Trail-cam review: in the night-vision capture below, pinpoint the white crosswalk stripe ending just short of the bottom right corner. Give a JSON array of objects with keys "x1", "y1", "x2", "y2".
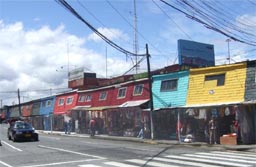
[{"x1": 166, "y1": 155, "x2": 250, "y2": 167}]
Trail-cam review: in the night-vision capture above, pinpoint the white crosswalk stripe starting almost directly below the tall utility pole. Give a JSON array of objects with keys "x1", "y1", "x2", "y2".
[{"x1": 148, "y1": 157, "x2": 223, "y2": 167}]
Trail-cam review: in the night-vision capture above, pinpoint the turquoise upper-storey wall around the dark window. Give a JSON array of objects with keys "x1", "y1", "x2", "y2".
[{"x1": 152, "y1": 71, "x2": 189, "y2": 109}]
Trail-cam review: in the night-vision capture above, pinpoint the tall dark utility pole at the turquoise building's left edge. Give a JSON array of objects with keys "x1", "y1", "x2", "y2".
[{"x1": 146, "y1": 44, "x2": 154, "y2": 140}]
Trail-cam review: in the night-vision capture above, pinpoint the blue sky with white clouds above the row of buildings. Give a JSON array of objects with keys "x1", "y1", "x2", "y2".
[{"x1": 0, "y1": 0, "x2": 256, "y2": 104}]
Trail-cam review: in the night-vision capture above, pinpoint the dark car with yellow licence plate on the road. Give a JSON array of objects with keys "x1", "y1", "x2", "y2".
[{"x1": 7, "y1": 121, "x2": 39, "y2": 142}]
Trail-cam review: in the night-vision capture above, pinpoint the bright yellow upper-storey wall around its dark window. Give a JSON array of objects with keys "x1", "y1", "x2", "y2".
[{"x1": 187, "y1": 63, "x2": 246, "y2": 105}]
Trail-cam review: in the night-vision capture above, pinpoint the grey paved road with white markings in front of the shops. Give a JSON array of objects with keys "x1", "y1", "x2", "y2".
[{"x1": 0, "y1": 125, "x2": 256, "y2": 167}]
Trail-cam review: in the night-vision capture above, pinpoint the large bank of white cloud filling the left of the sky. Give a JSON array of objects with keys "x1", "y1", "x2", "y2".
[{"x1": 0, "y1": 21, "x2": 130, "y2": 104}]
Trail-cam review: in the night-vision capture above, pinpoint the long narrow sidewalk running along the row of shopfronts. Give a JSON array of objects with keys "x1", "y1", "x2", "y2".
[{"x1": 37, "y1": 130, "x2": 256, "y2": 152}]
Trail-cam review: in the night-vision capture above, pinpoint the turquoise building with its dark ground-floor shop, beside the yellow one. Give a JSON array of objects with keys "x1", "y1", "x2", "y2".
[{"x1": 152, "y1": 70, "x2": 189, "y2": 139}]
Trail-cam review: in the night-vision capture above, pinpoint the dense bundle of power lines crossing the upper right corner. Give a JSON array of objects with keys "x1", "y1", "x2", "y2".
[{"x1": 160, "y1": 0, "x2": 256, "y2": 46}]
